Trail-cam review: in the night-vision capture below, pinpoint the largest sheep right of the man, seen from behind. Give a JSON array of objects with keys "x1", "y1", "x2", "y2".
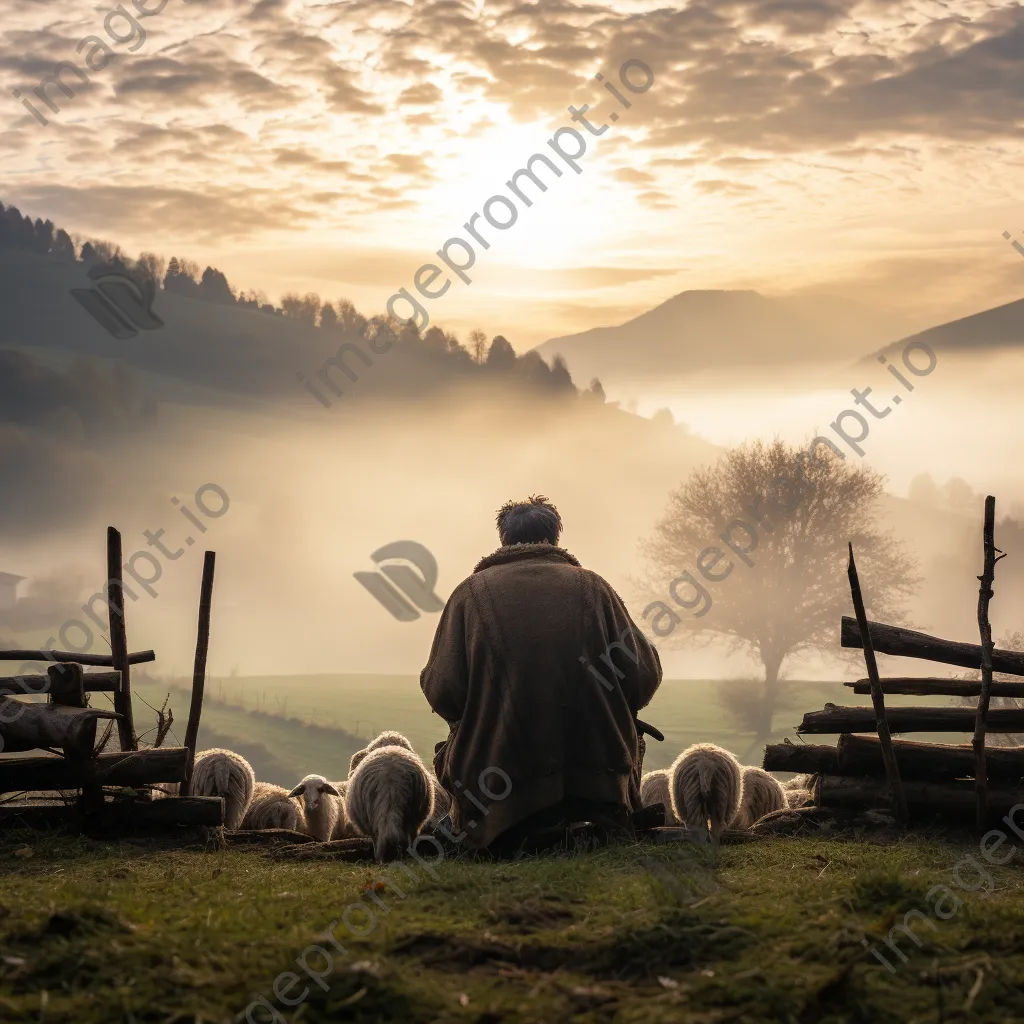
[{"x1": 669, "y1": 743, "x2": 743, "y2": 844}]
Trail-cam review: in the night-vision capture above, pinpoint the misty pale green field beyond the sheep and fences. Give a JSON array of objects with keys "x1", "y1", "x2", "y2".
[{"x1": 134, "y1": 675, "x2": 978, "y2": 784}]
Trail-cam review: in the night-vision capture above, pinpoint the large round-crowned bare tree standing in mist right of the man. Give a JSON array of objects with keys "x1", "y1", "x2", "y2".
[{"x1": 643, "y1": 439, "x2": 920, "y2": 741}]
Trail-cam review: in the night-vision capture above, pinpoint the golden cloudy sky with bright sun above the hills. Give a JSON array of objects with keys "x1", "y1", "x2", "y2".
[{"x1": 0, "y1": 0, "x2": 1024, "y2": 350}]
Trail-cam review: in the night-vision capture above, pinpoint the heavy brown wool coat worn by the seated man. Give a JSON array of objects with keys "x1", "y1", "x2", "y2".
[{"x1": 420, "y1": 544, "x2": 662, "y2": 848}]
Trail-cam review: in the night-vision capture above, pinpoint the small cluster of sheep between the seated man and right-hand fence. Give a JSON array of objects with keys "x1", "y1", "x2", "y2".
[{"x1": 640, "y1": 743, "x2": 810, "y2": 843}]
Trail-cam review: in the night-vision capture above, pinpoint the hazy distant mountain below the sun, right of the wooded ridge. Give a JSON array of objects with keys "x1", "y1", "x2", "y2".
[{"x1": 536, "y1": 291, "x2": 907, "y2": 385}]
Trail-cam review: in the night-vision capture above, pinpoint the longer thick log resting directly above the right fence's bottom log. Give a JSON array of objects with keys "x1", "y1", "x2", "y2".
[{"x1": 828, "y1": 733, "x2": 1024, "y2": 783}]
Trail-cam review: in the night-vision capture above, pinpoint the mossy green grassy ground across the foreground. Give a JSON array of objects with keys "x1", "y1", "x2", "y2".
[{"x1": 0, "y1": 833, "x2": 1024, "y2": 1024}]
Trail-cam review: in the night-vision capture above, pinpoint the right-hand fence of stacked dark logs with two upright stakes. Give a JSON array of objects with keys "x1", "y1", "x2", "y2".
[{"x1": 764, "y1": 497, "x2": 1024, "y2": 827}]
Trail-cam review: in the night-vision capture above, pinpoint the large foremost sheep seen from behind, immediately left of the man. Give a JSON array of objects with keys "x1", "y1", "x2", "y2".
[{"x1": 345, "y1": 746, "x2": 434, "y2": 863}]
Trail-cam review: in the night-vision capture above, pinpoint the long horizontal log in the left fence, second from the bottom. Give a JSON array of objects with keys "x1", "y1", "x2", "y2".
[{"x1": 0, "y1": 746, "x2": 188, "y2": 793}]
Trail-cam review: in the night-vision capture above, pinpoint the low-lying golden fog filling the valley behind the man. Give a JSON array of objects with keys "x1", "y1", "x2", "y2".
[{"x1": 0, "y1": 354, "x2": 1024, "y2": 677}]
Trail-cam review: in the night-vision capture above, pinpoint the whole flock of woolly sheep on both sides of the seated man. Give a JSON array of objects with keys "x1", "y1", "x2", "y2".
[{"x1": 169, "y1": 732, "x2": 809, "y2": 862}]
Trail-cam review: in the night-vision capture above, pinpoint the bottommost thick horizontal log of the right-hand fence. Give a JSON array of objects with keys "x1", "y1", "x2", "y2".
[{"x1": 819, "y1": 775, "x2": 1021, "y2": 821}]
